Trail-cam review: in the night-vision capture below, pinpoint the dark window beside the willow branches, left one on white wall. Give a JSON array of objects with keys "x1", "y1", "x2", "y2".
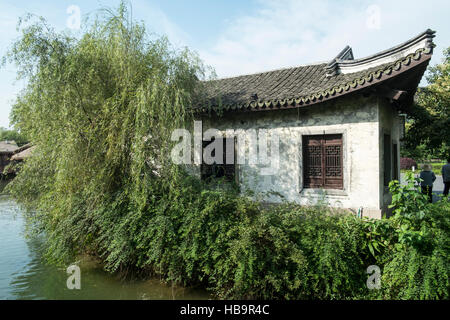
[{"x1": 201, "y1": 138, "x2": 236, "y2": 181}]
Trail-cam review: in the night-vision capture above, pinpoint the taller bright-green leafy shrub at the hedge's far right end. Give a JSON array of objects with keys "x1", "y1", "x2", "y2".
[{"x1": 380, "y1": 173, "x2": 450, "y2": 299}]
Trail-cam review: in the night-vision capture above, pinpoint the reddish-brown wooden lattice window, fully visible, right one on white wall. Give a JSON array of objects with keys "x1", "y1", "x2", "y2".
[{"x1": 303, "y1": 134, "x2": 344, "y2": 189}]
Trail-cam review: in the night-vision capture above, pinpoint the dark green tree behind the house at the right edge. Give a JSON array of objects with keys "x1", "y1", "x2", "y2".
[{"x1": 405, "y1": 47, "x2": 450, "y2": 158}]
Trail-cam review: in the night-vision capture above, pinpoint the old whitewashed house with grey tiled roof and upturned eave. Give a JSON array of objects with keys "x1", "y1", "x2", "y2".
[{"x1": 198, "y1": 30, "x2": 434, "y2": 218}]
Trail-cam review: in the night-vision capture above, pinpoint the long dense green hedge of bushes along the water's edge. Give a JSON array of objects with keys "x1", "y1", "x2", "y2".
[{"x1": 10, "y1": 162, "x2": 450, "y2": 299}]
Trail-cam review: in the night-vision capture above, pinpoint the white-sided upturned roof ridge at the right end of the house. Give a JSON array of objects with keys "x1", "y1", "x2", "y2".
[{"x1": 325, "y1": 29, "x2": 436, "y2": 77}]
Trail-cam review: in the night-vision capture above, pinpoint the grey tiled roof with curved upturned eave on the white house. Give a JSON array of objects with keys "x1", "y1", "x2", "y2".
[{"x1": 200, "y1": 30, "x2": 434, "y2": 111}]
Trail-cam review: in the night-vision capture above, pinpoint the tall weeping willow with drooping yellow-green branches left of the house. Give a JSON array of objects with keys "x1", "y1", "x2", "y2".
[{"x1": 5, "y1": 4, "x2": 205, "y2": 269}]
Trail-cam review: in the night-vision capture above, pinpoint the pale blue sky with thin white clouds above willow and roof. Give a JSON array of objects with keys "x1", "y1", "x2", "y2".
[{"x1": 0, "y1": 0, "x2": 450, "y2": 127}]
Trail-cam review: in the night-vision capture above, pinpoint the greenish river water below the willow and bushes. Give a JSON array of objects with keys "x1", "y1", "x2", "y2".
[{"x1": 0, "y1": 194, "x2": 210, "y2": 300}]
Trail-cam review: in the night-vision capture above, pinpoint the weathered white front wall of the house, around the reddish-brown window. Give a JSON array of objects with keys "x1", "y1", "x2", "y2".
[{"x1": 203, "y1": 95, "x2": 382, "y2": 216}]
